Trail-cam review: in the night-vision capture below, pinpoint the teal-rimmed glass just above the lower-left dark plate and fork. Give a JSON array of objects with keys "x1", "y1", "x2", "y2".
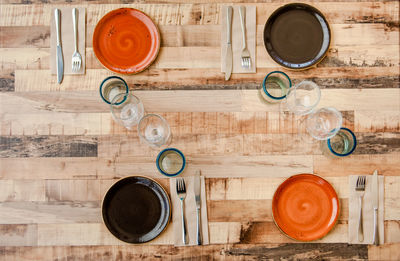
[{"x1": 156, "y1": 148, "x2": 186, "y2": 177}]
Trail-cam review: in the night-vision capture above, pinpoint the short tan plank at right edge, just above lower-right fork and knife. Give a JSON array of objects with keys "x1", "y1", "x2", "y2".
[{"x1": 313, "y1": 154, "x2": 400, "y2": 176}]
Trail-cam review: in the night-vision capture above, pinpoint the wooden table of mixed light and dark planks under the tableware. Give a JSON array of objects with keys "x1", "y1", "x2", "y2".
[{"x1": 0, "y1": 0, "x2": 400, "y2": 261}]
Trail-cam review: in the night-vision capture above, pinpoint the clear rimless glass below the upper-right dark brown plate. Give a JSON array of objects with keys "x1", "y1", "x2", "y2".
[{"x1": 285, "y1": 81, "x2": 321, "y2": 115}]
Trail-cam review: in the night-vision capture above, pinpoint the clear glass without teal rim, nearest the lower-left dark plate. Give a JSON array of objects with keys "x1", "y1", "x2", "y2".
[{"x1": 138, "y1": 114, "x2": 171, "y2": 148}]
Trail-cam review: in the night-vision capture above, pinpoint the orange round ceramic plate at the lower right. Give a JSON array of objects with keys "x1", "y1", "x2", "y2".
[{"x1": 272, "y1": 174, "x2": 339, "y2": 241}]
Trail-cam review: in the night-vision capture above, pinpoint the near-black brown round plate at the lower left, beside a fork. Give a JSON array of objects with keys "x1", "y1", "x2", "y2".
[{"x1": 102, "y1": 176, "x2": 171, "y2": 243}]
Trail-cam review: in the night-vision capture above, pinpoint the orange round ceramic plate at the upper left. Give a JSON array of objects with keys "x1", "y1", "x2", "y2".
[{"x1": 93, "y1": 8, "x2": 160, "y2": 74}]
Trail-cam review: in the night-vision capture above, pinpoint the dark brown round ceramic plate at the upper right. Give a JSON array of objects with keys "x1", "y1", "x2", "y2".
[{"x1": 264, "y1": 3, "x2": 331, "y2": 69}]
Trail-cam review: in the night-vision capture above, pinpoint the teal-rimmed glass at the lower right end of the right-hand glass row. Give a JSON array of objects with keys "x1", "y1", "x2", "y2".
[{"x1": 321, "y1": 128, "x2": 357, "y2": 157}]
